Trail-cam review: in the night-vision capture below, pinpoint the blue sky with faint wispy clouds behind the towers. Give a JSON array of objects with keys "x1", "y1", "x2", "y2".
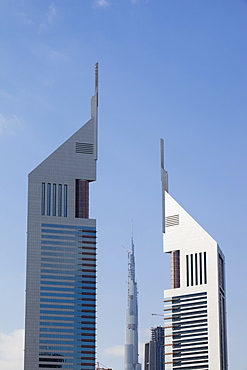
[{"x1": 0, "y1": 0, "x2": 247, "y2": 370}]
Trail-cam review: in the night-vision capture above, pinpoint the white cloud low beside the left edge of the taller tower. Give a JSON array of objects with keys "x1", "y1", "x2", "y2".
[{"x1": 0, "y1": 329, "x2": 24, "y2": 370}]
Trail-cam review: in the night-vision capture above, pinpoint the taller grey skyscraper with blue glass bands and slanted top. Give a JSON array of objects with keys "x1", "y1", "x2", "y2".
[{"x1": 24, "y1": 64, "x2": 98, "y2": 370}]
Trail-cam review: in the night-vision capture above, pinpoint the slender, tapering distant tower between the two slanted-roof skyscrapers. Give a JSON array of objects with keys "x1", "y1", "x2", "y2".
[{"x1": 124, "y1": 236, "x2": 141, "y2": 370}]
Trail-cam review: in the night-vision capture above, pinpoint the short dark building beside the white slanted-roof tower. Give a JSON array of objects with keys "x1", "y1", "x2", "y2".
[{"x1": 144, "y1": 326, "x2": 165, "y2": 370}]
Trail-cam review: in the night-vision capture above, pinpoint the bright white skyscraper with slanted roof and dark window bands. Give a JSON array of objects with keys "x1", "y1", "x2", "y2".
[{"x1": 161, "y1": 140, "x2": 228, "y2": 370}]
